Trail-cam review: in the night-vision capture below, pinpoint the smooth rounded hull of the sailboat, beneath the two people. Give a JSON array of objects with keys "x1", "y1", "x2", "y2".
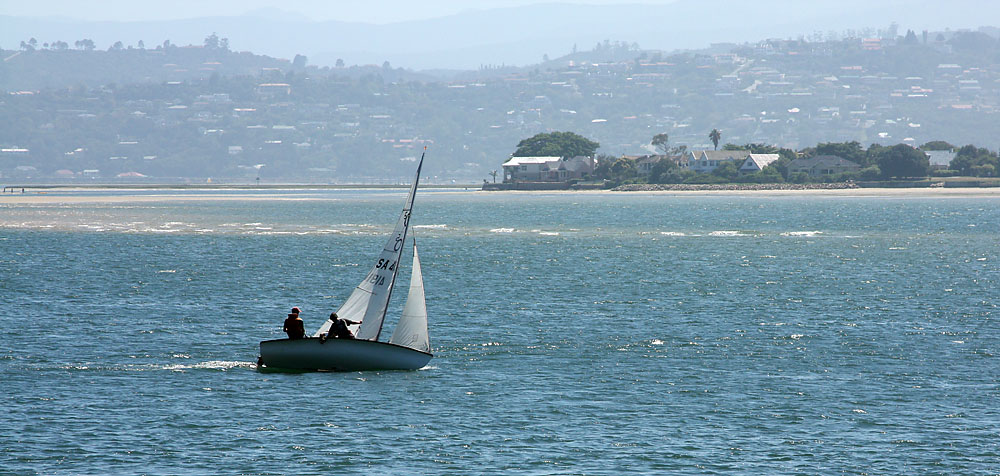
[{"x1": 259, "y1": 338, "x2": 434, "y2": 372}]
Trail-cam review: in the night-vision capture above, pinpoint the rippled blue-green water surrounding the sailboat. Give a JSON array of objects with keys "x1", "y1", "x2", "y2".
[{"x1": 0, "y1": 191, "x2": 1000, "y2": 474}]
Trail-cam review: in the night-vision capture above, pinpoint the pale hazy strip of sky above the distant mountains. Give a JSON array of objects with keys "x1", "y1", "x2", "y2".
[{"x1": 0, "y1": 0, "x2": 675, "y2": 23}]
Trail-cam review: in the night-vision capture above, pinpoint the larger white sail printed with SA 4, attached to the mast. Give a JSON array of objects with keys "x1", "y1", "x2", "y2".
[{"x1": 314, "y1": 154, "x2": 424, "y2": 340}]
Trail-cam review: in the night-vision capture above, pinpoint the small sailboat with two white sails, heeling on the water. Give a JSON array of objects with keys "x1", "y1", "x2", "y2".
[{"x1": 257, "y1": 151, "x2": 433, "y2": 371}]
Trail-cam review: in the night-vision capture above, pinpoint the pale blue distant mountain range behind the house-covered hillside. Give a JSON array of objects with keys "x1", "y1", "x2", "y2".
[{"x1": 0, "y1": 0, "x2": 1000, "y2": 70}]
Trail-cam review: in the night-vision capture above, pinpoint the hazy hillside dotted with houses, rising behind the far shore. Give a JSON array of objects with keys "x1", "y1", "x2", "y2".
[{"x1": 0, "y1": 25, "x2": 1000, "y2": 183}]
